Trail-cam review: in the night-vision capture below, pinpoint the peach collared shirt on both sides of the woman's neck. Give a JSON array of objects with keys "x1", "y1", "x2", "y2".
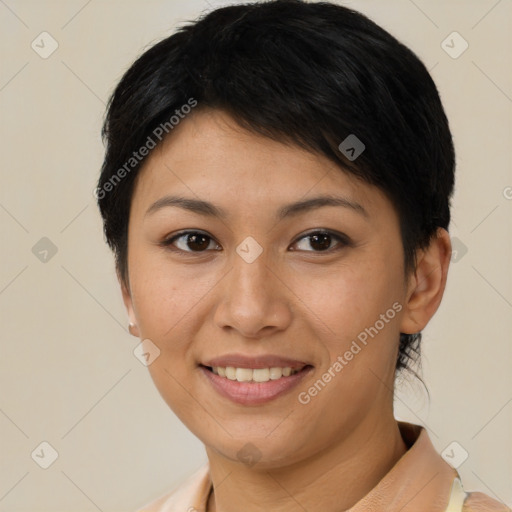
[{"x1": 138, "y1": 421, "x2": 512, "y2": 512}]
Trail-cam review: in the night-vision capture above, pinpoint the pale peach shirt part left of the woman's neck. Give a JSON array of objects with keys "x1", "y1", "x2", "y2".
[{"x1": 137, "y1": 464, "x2": 211, "y2": 512}]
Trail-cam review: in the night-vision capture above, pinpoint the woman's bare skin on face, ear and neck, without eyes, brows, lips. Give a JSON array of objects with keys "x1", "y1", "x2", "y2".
[{"x1": 121, "y1": 110, "x2": 451, "y2": 512}]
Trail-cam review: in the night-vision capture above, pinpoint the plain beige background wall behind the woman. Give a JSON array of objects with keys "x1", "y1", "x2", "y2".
[{"x1": 0, "y1": 0, "x2": 512, "y2": 512}]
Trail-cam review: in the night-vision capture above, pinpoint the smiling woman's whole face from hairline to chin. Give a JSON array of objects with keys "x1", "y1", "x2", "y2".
[{"x1": 123, "y1": 111, "x2": 416, "y2": 467}]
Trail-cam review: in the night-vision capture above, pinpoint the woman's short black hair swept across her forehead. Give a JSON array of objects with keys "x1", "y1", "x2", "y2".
[{"x1": 96, "y1": 0, "x2": 455, "y2": 376}]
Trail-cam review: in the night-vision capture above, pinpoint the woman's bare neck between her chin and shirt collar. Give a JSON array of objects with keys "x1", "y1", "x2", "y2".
[{"x1": 207, "y1": 417, "x2": 407, "y2": 512}]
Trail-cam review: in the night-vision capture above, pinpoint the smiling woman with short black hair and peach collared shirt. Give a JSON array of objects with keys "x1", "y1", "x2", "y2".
[{"x1": 97, "y1": 0, "x2": 507, "y2": 512}]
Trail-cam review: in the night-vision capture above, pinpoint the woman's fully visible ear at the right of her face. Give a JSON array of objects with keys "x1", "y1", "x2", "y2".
[{"x1": 400, "y1": 228, "x2": 452, "y2": 334}]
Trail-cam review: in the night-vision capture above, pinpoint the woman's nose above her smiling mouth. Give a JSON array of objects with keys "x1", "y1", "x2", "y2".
[{"x1": 214, "y1": 252, "x2": 292, "y2": 338}]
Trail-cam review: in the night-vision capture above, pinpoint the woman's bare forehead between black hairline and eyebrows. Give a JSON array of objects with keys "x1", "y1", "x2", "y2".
[{"x1": 132, "y1": 110, "x2": 391, "y2": 221}]
